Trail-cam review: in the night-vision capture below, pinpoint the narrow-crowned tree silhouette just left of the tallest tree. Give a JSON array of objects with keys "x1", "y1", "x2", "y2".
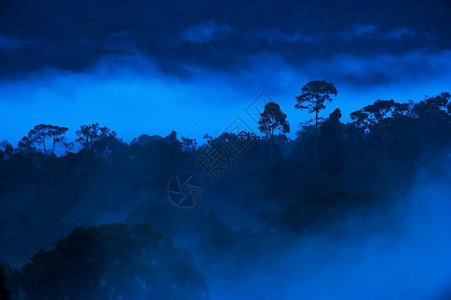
[{"x1": 258, "y1": 102, "x2": 290, "y2": 160}]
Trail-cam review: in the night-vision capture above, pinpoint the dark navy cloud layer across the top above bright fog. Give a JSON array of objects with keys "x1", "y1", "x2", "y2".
[{"x1": 0, "y1": 0, "x2": 451, "y2": 79}]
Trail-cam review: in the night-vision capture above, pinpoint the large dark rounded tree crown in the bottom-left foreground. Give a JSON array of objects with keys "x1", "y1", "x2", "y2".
[{"x1": 22, "y1": 224, "x2": 207, "y2": 299}]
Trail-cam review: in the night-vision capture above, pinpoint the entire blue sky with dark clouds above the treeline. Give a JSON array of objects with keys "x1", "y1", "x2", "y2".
[{"x1": 0, "y1": 0, "x2": 451, "y2": 144}]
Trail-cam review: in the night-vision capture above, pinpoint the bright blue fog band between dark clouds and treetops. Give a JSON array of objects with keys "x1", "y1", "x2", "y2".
[{"x1": 0, "y1": 51, "x2": 451, "y2": 145}]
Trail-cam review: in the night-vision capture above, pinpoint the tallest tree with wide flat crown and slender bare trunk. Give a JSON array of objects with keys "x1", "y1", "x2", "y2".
[{"x1": 294, "y1": 80, "x2": 338, "y2": 158}]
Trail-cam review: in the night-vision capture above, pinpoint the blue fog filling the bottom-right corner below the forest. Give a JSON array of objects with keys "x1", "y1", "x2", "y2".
[{"x1": 206, "y1": 173, "x2": 451, "y2": 299}]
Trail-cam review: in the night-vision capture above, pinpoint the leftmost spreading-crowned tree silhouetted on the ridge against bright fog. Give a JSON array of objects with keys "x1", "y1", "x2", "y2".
[{"x1": 26, "y1": 124, "x2": 69, "y2": 153}]
